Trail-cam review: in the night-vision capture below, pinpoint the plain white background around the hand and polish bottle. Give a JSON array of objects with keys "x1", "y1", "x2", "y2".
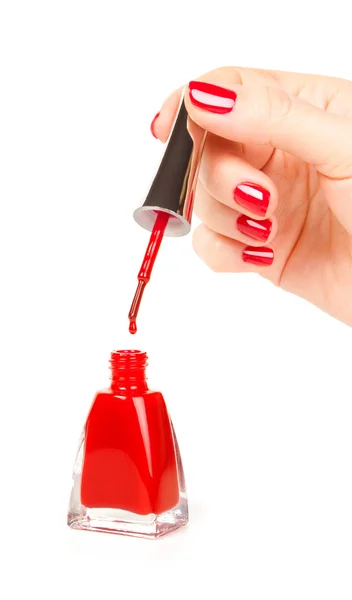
[{"x1": 0, "y1": 0, "x2": 352, "y2": 600}]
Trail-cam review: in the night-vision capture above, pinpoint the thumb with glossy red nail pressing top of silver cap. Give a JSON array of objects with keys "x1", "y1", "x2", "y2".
[{"x1": 185, "y1": 81, "x2": 352, "y2": 234}]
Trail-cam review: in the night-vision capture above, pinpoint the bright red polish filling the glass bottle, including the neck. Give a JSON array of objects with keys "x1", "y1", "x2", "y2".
[{"x1": 81, "y1": 351, "x2": 179, "y2": 515}]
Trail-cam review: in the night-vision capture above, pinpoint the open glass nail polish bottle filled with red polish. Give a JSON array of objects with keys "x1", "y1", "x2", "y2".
[{"x1": 68, "y1": 350, "x2": 188, "y2": 538}]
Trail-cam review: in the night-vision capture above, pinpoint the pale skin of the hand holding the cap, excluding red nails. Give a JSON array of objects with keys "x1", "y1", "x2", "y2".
[{"x1": 154, "y1": 67, "x2": 352, "y2": 327}]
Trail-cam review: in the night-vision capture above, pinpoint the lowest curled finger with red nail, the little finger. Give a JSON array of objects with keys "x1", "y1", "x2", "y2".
[{"x1": 193, "y1": 224, "x2": 279, "y2": 274}]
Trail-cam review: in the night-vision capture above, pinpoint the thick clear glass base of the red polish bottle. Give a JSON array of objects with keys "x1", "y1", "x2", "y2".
[{"x1": 67, "y1": 494, "x2": 188, "y2": 539}]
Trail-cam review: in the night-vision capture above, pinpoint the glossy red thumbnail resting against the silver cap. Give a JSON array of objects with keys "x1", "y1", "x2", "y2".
[{"x1": 188, "y1": 81, "x2": 237, "y2": 115}]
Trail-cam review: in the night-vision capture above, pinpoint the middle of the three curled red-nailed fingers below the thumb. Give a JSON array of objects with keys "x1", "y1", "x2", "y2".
[{"x1": 195, "y1": 183, "x2": 277, "y2": 246}]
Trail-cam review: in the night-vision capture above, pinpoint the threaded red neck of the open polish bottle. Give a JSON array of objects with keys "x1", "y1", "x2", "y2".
[{"x1": 110, "y1": 350, "x2": 148, "y2": 393}]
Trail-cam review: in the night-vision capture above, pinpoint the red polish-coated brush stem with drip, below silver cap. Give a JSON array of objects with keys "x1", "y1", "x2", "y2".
[{"x1": 128, "y1": 212, "x2": 170, "y2": 334}]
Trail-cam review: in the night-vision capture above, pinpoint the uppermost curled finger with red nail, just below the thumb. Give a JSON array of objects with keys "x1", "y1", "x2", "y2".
[{"x1": 200, "y1": 136, "x2": 278, "y2": 219}]
